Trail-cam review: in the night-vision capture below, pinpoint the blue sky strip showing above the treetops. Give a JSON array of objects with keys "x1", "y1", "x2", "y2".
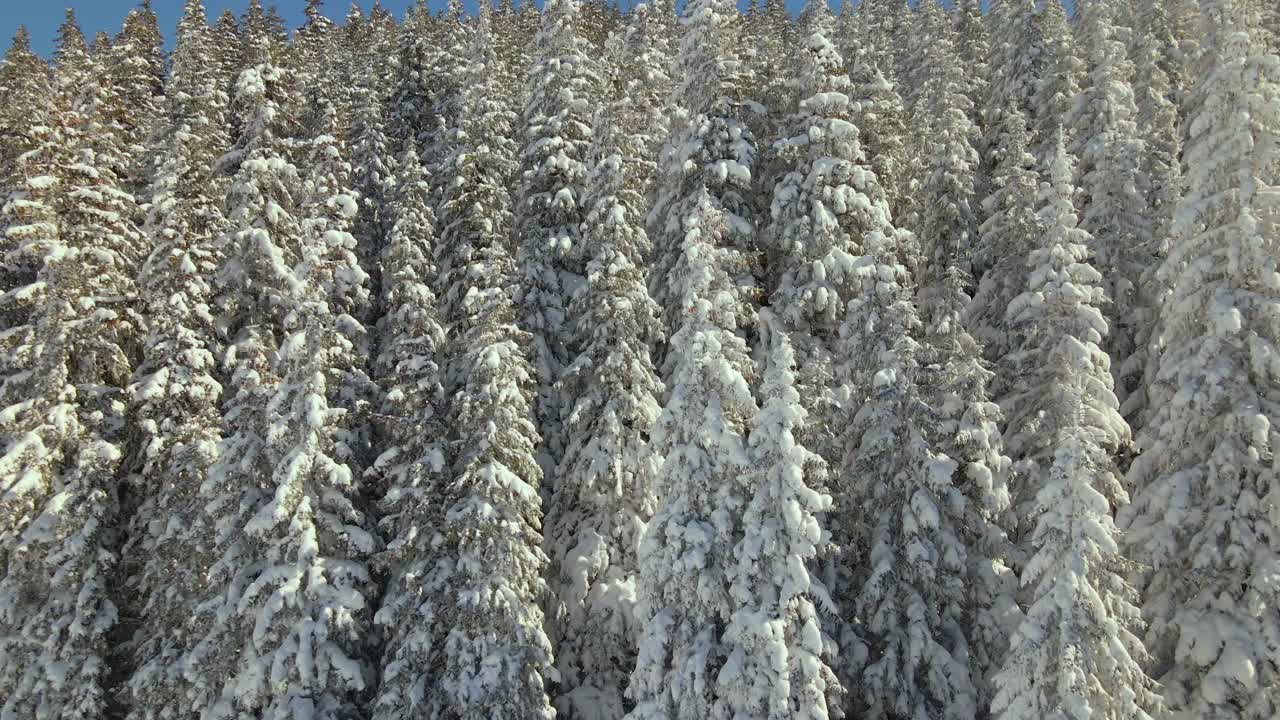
[{"x1": 0, "y1": 0, "x2": 819, "y2": 56}]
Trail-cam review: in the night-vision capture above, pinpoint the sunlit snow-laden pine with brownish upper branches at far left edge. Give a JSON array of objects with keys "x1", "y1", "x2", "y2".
[{"x1": 0, "y1": 85, "x2": 129, "y2": 720}]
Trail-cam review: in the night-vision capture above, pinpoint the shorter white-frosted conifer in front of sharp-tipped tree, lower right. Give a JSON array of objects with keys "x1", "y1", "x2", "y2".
[{"x1": 991, "y1": 420, "x2": 1162, "y2": 720}]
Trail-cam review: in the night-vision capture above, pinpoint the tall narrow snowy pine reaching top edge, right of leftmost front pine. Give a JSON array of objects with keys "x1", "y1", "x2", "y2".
[{"x1": 123, "y1": 0, "x2": 227, "y2": 720}]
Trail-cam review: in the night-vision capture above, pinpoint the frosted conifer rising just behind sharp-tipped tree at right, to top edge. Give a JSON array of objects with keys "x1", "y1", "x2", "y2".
[{"x1": 1068, "y1": 0, "x2": 1153, "y2": 409}]
